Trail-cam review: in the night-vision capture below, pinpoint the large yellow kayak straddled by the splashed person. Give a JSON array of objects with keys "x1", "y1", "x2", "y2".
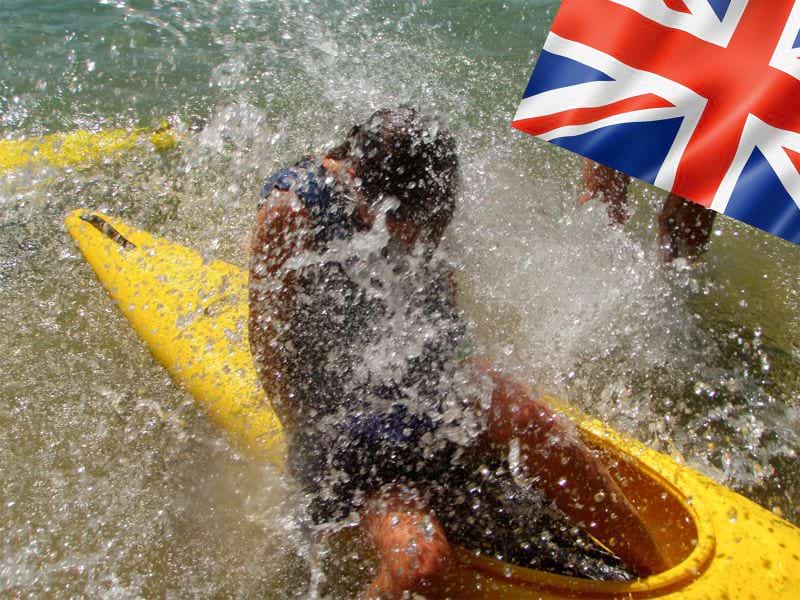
[{"x1": 66, "y1": 210, "x2": 800, "y2": 600}]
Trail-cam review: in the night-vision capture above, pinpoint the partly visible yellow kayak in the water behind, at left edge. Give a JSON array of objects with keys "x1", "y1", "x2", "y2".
[{"x1": 0, "y1": 125, "x2": 178, "y2": 174}]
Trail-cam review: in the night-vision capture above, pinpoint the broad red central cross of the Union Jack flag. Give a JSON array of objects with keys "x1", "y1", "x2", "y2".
[{"x1": 552, "y1": 0, "x2": 800, "y2": 206}]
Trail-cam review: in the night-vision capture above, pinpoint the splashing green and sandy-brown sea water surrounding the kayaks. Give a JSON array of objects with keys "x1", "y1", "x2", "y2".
[{"x1": 0, "y1": 0, "x2": 800, "y2": 598}]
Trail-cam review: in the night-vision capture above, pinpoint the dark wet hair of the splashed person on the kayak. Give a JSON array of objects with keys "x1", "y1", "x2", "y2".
[{"x1": 330, "y1": 106, "x2": 458, "y2": 243}]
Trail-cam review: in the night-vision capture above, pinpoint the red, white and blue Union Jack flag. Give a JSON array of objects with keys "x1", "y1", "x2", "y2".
[{"x1": 513, "y1": 0, "x2": 800, "y2": 244}]
